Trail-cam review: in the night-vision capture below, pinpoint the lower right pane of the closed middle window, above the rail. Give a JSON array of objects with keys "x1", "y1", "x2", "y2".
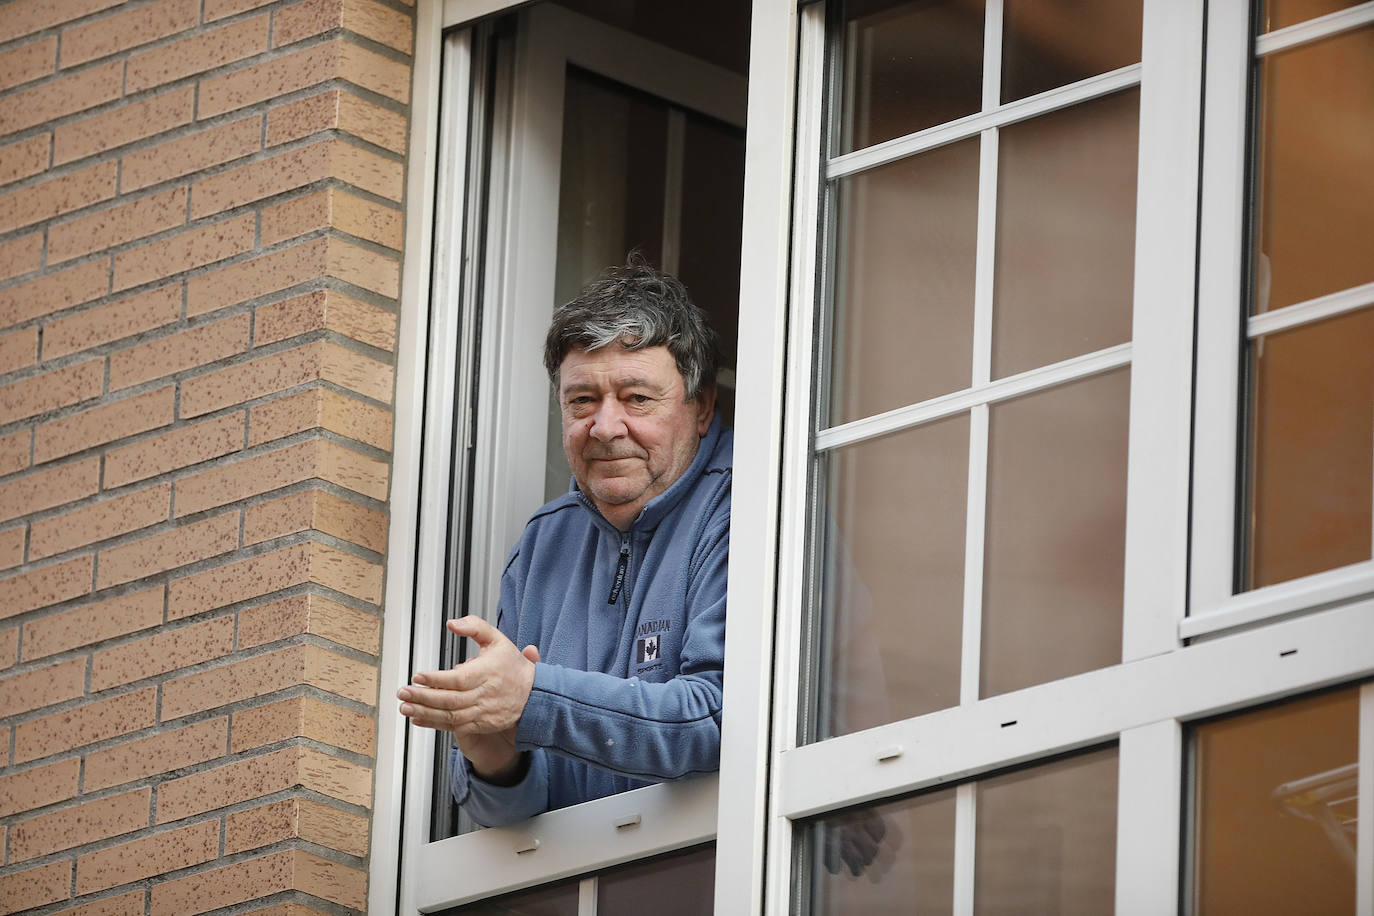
[{"x1": 980, "y1": 368, "x2": 1131, "y2": 696}]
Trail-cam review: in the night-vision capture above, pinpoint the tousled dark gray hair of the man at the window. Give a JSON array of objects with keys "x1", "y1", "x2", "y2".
[{"x1": 544, "y1": 251, "x2": 720, "y2": 400}]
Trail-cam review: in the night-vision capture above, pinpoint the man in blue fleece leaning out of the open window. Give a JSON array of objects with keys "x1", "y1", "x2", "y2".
[{"x1": 397, "y1": 257, "x2": 732, "y2": 825}]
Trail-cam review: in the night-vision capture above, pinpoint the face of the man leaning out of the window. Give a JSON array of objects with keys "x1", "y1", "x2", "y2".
[{"x1": 558, "y1": 343, "x2": 716, "y2": 530}]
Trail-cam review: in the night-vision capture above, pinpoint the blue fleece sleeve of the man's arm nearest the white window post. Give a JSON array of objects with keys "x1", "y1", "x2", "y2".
[{"x1": 515, "y1": 518, "x2": 730, "y2": 780}]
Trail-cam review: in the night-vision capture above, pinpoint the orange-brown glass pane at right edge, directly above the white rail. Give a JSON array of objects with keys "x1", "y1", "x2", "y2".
[{"x1": 1246, "y1": 309, "x2": 1374, "y2": 588}]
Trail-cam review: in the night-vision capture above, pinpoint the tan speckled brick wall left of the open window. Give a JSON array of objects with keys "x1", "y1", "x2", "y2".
[{"x1": 0, "y1": 0, "x2": 414, "y2": 916}]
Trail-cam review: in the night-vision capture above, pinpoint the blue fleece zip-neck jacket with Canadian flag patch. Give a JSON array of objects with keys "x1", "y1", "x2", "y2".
[{"x1": 451, "y1": 417, "x2": 734, "y2": 827}]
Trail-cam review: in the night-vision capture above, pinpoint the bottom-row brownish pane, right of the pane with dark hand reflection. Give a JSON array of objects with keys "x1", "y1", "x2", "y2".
[{"x1": 973, "y1": 747, "x2": 1115, "y2": 916}]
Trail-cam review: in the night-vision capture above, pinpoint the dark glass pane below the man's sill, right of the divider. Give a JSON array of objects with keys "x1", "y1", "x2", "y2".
[{"x1": 596, "y1": 846, "x2": 716, "y2": 916}]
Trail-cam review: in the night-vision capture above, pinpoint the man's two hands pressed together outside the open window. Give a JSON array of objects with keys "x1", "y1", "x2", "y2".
[{"x1": 396, "y1": 617, "x2": 539, "y2": 779}]
